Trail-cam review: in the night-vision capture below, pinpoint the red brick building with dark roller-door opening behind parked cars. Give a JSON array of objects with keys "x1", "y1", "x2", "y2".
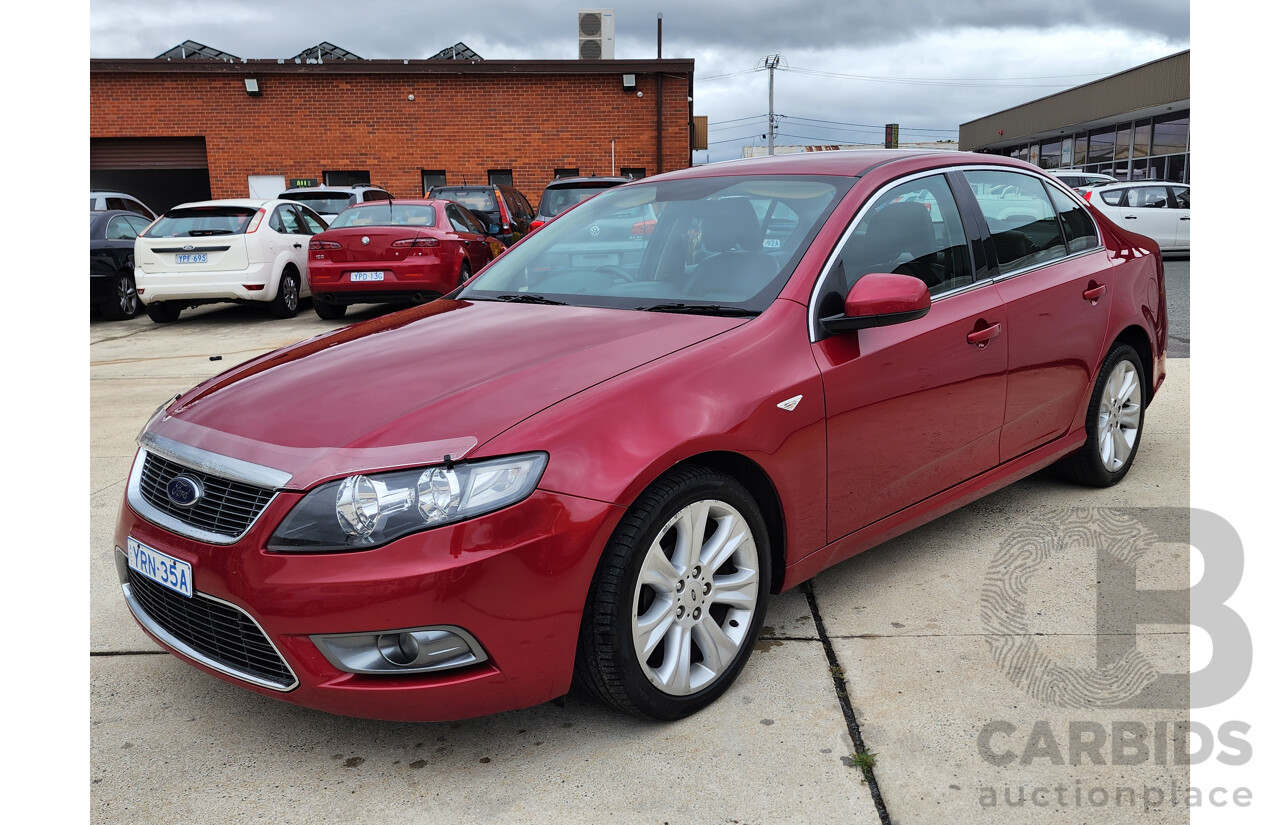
[{"x1": 90, "y1": 59, "x2": 694, "y2": 210}]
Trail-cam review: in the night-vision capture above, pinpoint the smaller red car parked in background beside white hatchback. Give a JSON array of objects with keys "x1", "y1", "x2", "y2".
[{"x1": 307, "y1": 200, "x2": 506, "y2": 320}]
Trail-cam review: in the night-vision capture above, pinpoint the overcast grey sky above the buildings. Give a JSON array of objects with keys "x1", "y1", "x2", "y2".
[{"x1": 90, "y1": 0, "x2": 1190, "y2": 162}]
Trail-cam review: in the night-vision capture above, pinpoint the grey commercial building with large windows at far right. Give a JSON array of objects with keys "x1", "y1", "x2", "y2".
[{"x1": 960, "y1": 50, "x2": 1192, "y2": 183}]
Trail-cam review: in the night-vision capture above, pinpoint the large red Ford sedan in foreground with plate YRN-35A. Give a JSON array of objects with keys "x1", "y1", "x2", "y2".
[{"x1": 115, "y1": 151, "x2": 1167, "y2": 720}]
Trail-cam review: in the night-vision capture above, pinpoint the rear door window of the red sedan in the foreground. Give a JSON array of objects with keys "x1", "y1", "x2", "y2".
[{"x1": 964, "y1": 170, "x2": 1066, "y2": 272}]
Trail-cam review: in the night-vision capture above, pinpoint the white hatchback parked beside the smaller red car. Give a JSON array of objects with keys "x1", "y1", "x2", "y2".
[{"x1": 133, "y1": 198, "x2": 329, "y2": 324}]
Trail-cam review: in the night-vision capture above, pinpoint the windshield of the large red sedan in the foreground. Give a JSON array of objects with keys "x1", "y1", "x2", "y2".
[{"x1": 460, "y1": 175, "x2": 852, "y2": 315}]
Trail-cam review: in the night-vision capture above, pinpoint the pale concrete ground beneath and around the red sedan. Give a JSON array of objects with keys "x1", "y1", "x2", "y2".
[{"x1": 90, "y1": 304, "x2": 1190, "y2": 825}]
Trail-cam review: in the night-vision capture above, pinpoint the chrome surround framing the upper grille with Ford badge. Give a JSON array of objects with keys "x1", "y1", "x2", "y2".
[{"x1": 125, "y1": 432, "x2": 292, "y2": 545}]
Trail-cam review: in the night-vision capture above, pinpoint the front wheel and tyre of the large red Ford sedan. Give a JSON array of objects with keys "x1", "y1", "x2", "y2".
[{"x1": 576, "y1": 467, "x2": 769, "y2": 720}]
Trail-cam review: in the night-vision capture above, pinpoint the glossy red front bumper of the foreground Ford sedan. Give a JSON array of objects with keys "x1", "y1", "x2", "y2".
[{"x1": 115, "y1": 478, "x2": 623, "y2": 721}]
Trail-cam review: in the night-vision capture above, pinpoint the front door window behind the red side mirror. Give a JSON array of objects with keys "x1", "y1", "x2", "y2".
[{"x1": 819, "y1": 175, "x2": 973, "y2": 316}]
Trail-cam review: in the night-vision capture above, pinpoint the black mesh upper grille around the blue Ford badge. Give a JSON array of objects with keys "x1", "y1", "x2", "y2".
[{"x1": 138, "y1": 452, "x2": 273, "y2": 537}]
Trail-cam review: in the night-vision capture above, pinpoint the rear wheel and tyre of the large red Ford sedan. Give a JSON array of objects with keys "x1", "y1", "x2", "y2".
[{"x1": 1055, "y1": 344, "x2": 1147, "y2": 487}]
